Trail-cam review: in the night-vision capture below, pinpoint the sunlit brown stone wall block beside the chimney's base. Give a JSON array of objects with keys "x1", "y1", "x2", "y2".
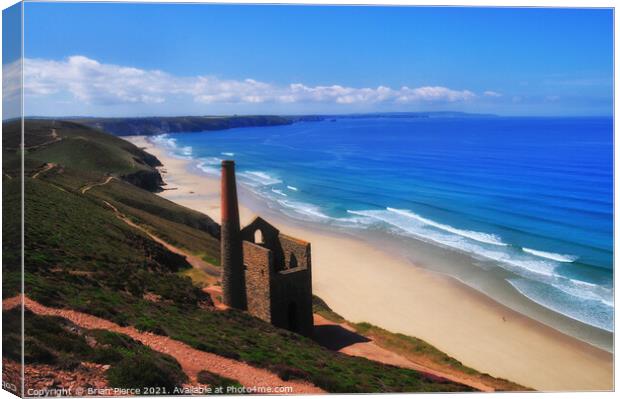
[{"x1": 243, "y1": 241, "x2": 273, "y2": 323}]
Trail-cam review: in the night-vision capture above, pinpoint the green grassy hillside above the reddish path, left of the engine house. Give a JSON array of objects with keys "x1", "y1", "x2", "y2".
[{"x1": 3, "y1": 121, "x2": 470, "y2": 392}]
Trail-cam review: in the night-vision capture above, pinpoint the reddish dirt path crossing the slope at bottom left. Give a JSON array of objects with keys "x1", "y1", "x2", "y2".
[{"x1": 2, "y1": 297, "x2": 324, "y2": 394}]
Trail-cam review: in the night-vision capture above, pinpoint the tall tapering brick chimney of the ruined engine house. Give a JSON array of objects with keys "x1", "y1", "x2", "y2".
[{"x1": 220, "y1": 160, "x2": 246, "y2": 310}]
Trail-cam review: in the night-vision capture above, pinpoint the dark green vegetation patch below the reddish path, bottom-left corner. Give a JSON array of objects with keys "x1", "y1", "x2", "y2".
[{"x1": 2, "y1": 308, "x2": 188, "y2": 391}]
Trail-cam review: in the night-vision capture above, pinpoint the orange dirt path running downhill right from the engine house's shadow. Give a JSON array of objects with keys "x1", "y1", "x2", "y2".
[{"x1": 314, "y1": 314, "x2": 494, "y2": 392}]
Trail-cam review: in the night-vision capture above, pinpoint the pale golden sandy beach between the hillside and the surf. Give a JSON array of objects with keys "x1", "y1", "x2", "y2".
[{"x1": 124, "y1": 136, "x2": 613, "y2": 391}]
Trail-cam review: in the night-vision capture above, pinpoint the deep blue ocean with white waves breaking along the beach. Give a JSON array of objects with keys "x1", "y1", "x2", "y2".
[{"x1": 153, "y1": 117, "x2": 614, "y2": 331}]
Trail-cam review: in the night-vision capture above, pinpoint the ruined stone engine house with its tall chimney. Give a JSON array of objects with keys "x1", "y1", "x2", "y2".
[{"x1": 221, "y1": 161, "x2": 313, "y2": 336}]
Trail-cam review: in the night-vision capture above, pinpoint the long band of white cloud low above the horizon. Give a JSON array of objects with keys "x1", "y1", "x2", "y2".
[{"x1": 24, "y1": 55, "x2": 480, "y2": 111}]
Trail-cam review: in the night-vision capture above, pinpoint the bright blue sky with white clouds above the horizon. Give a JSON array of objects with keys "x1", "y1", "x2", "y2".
[{"x1": 4, "y1": 2, "x2": 613, "y2": 116}]
